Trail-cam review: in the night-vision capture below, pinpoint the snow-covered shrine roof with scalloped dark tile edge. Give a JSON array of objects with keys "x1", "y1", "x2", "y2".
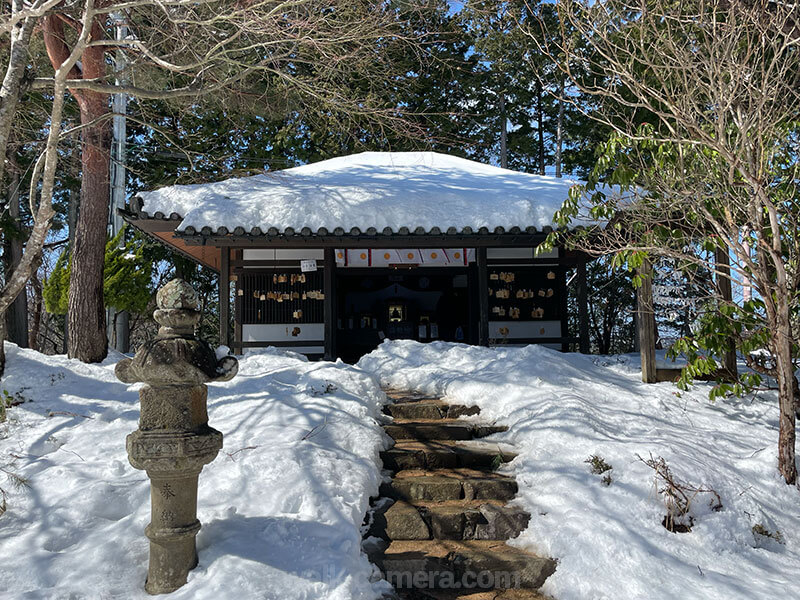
[{"x1": 134, "y1": 152, "x2": 592, "y2": 235}]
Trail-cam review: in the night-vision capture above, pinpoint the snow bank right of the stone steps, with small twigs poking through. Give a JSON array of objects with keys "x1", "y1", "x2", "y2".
[{"x1": 359, "y1": 341, "x2": 800, "y2": 600}]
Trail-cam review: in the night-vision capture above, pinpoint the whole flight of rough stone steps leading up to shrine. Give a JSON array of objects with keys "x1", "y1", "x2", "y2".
[{"x1": 367, "y1": 391, "x2": 556, "y2": 600}]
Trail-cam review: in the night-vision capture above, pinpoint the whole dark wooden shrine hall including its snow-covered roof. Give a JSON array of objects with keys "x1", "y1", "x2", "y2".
[{"x1": 124, "y1": 152, "x2": 589, "y2": 361}]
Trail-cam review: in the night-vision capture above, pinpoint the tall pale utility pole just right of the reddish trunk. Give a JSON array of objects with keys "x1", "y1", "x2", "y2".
[{"x1": 107, "y1": 13, "x2": 130, "y2": 352}]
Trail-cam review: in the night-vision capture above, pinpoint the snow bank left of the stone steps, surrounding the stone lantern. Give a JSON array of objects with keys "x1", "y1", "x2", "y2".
[{"x1": 0, "y1": 344, "x2": 387, "y2": 600}]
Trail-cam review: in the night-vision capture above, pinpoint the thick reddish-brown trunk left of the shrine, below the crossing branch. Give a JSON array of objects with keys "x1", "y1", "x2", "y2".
[{"x1": 67, "y1": 94, "x2": 110, "y2": 362}]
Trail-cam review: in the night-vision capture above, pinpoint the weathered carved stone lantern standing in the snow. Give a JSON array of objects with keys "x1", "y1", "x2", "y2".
[{"x1": 116, "y1": 279, "x2": 239, "y2": 594}]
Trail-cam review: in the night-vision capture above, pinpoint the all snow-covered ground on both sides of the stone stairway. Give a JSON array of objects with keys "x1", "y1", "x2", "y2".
[{"x1": 0, "y1": 342, "x2": 800, "y2": 600}]
